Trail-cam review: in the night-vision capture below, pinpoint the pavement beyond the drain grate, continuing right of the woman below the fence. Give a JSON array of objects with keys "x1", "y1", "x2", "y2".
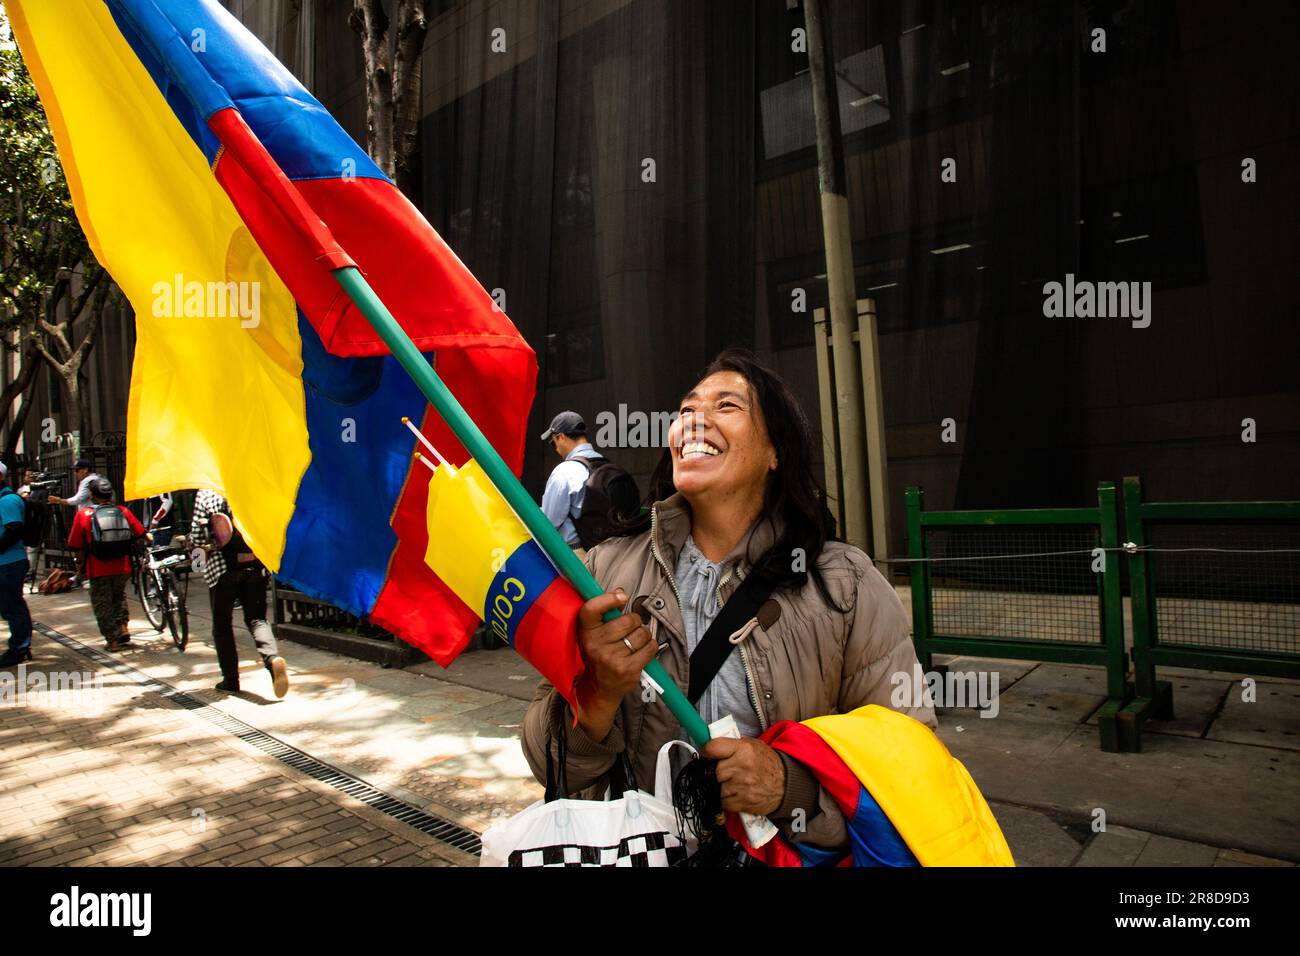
[{"x1": 10, "y1": 581, "x2": 1300, "y2": 866}]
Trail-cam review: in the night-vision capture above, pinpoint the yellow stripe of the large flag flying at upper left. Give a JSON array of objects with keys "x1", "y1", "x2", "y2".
[{"x1": 5, "y1": 0, "x2": 311, "y2": 570}]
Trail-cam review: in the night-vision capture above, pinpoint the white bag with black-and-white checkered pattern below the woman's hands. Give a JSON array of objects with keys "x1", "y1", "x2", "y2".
[{"x1": 478, "y1": 740, "x2": 696, "y2": 866}]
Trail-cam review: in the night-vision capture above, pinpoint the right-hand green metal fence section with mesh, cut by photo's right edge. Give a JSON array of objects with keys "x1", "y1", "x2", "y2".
[{"x1": 1121, "y1": 477, "x2": 1300, "y2": 750}]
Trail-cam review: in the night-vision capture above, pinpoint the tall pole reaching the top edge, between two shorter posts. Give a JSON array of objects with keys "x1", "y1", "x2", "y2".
[{"x1": 803, "y1": 0, "x2": 867, "y2": 548}]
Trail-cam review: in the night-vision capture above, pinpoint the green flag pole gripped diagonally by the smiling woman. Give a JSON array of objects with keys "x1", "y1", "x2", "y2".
[{"x1": 334, "y1": 265, "x2": 709, "y2": 745}]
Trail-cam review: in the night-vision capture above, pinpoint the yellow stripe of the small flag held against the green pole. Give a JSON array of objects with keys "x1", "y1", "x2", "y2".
[{"x1": 424, "y1": 462, "x2": 528, "y2": 617}]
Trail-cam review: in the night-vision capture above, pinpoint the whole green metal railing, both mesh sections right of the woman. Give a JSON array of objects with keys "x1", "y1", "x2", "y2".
[{"x1": 892, "y1": 477, "x2": 1300, "y2": 752}]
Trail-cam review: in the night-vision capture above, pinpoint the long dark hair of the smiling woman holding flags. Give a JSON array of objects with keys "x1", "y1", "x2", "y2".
[{"x1": 620, "y1": 349, "x2": 844, "y2": 610}]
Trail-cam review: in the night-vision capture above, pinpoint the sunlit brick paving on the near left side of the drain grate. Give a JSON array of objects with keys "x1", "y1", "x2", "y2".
[{"x1": 0, "y1": 616, "x2": 473, "y2": 866}]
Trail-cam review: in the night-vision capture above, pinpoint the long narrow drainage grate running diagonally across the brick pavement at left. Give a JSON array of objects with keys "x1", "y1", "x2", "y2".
[{"x1": 33, "y1": 622, "x2": 482, "y2": 856}]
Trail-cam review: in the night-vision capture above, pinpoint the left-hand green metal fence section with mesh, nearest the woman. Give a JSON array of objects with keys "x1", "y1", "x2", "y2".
[{"x1": 906, "y1": 481, "x2": 1127, "y2": 750}]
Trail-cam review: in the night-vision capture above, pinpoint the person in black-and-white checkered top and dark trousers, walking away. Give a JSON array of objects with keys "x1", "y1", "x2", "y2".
[{"x1": 190, "y1": 489, "x2": 289, "y2": 697}]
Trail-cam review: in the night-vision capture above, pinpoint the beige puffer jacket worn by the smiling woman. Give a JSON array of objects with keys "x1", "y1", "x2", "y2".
[{"x1": 523, "y1": 494, "x2": 937, "y2": 845}]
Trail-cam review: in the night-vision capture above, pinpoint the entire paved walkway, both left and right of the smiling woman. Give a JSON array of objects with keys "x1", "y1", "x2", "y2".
[{"x1": 0, "y1": 583, "x2": 1300, "y2": 866}]
